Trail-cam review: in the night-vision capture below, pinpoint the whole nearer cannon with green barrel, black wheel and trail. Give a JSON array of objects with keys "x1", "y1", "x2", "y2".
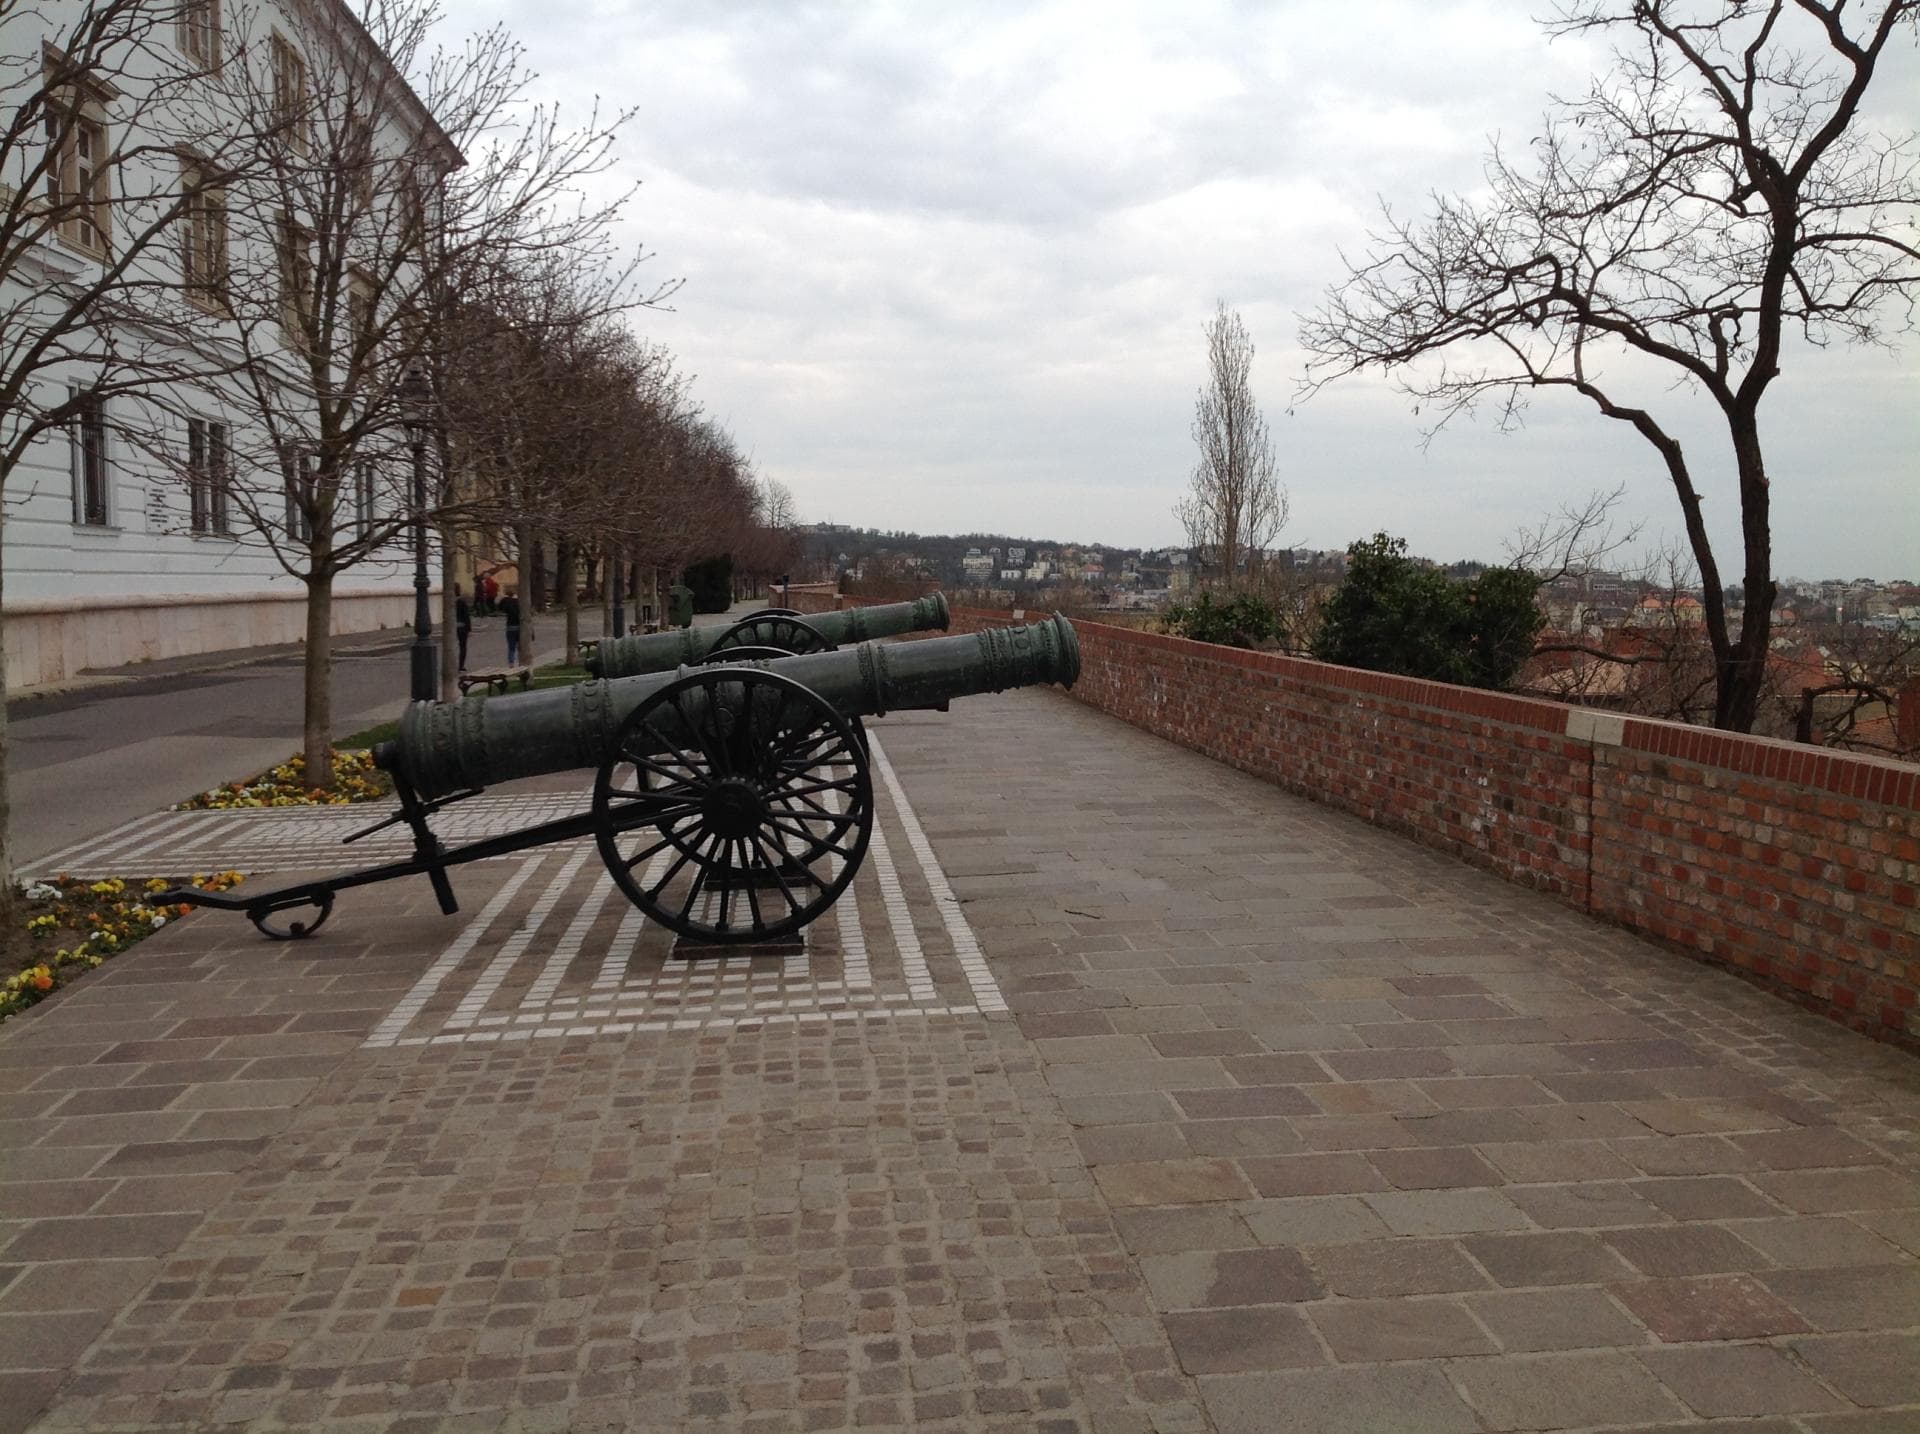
[{"x1": 159, "y1": 603, "x2": 1079, "y2": 944}]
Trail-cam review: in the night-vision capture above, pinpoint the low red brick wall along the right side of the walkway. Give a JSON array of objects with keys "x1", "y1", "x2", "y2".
[{"x1": 795, "y1": 593, "x2": 1920, "y2": 1048}]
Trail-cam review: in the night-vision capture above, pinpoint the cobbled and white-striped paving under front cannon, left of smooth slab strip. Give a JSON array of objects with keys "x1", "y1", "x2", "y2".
[{"x1": 0, "y1": 735, "x2": 1204, "y2": 1434}]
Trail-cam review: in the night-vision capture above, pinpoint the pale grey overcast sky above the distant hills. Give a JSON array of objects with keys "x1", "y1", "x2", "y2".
[{"x1": 451, "y1": 0, "x2": 1920, "y2": 578}]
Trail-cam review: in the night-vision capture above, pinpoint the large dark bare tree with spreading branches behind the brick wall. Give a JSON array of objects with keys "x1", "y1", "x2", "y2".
[{"x1": 1302, "y1": 0, "x2": 1920, "y2": 731}]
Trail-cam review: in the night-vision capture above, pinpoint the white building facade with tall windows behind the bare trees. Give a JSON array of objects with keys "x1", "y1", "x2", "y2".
[{"x1": 0, "y1": 0, "x2": 459, "y2": 689}]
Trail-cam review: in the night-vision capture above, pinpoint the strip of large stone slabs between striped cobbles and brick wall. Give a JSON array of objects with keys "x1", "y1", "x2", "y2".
[{"x1": 895, "y1": 695, "x2": 1920, "y2": 1434}]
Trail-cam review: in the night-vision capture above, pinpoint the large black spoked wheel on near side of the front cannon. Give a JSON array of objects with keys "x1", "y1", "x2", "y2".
[{"x1": 593, "y1": 666, "x2": 874, "y2": 944}]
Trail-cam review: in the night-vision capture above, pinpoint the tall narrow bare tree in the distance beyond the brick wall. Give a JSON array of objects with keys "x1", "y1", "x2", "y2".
[{"x1": 1173, "y1": 303, "x2": 1286, "y2": 586}]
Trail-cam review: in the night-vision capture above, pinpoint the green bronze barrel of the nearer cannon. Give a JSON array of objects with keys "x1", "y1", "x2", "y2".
[{"x1": 374, "y1": 605, "x2": 1079, "y2": 799}]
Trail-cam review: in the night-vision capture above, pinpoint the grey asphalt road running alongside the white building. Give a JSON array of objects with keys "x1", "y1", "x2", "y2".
[{"x1": 8, "y1": 628, "x2": 426, "y2": 870}]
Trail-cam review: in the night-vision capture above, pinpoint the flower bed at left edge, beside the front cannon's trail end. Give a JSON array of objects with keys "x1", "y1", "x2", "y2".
[{"x1": 0, "y1": 872, "x2": 244, "y2": 1021}]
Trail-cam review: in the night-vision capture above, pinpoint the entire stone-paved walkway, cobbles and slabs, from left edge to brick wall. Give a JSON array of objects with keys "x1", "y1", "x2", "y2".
[{"x1": 0, "y1": 693, "x2": 1920, "y2": 1434}]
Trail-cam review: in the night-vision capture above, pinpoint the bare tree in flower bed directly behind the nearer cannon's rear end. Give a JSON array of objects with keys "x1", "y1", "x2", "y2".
[{"x1": 156, "y1": 0, "x2": 648, "y2": 785}]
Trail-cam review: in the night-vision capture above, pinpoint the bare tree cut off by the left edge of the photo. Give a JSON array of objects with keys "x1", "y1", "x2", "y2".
[{"x1": 0, "y1": 0, "x2": 266, "y2": 944}]
